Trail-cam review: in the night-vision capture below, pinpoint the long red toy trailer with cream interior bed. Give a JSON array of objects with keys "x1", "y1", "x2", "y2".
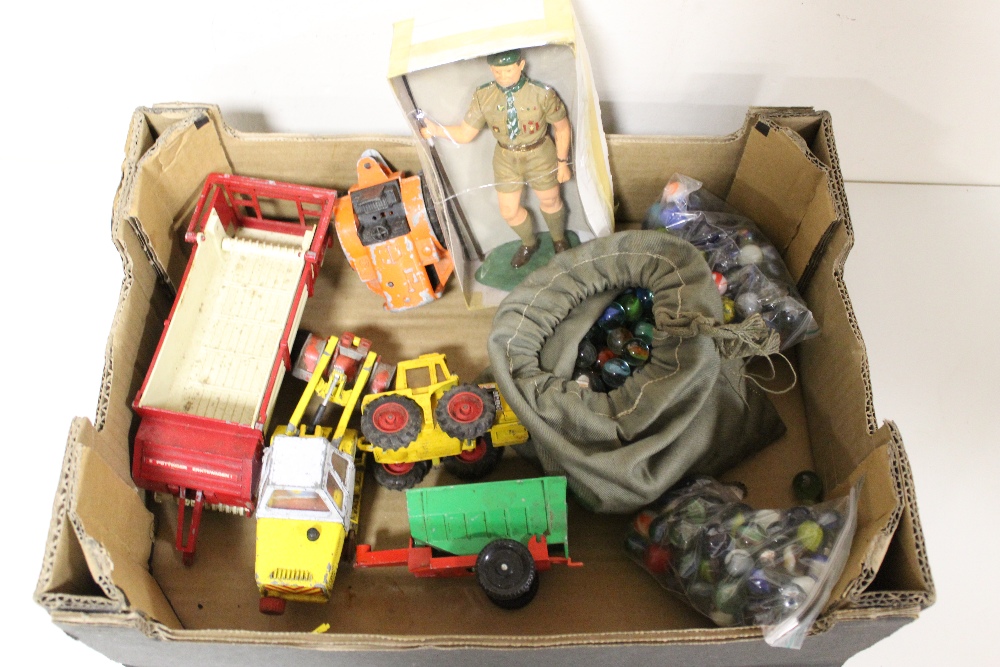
[{"x1": 132, "y1": 174, "x2": 337, "y2": 564}]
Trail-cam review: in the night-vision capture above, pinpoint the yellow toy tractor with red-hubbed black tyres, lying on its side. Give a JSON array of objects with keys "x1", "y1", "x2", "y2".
[{"x1": 358, "y1": 353, "x2": 528, "y2": 491}]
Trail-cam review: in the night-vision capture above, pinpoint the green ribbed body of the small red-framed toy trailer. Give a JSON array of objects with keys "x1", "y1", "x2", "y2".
[{"x1": 406, "y1": 477, "x2": 569, "y2": 557}]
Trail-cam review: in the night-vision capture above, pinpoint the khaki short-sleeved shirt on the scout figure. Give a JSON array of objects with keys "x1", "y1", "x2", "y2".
[{"x1": 465, "y1": 76, "x2": 566, "y2": 148}]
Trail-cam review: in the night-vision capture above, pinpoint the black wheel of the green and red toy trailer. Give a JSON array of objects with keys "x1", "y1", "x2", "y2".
[{"x1": 476, "y1": 539, "x2": 538, "y2": 609}]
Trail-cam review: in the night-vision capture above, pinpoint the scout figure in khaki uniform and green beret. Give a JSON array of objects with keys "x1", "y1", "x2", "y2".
[{"x1": 421, "y1": 49, "x2": 572, "y2": 269}]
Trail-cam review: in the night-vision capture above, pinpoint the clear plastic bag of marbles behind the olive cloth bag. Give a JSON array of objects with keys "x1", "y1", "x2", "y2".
[{"x1": 644, "y1": 174, "x2": 819, "y2": 350}]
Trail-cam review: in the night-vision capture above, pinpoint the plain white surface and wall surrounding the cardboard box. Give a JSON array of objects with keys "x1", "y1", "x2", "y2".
[{"x1": 0, "y1": 0, "x2": 1000, "y2": 667}]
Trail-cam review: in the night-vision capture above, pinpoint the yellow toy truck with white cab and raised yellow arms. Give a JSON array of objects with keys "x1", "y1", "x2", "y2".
[{"x1": 254, "y1": 334, "x2": 391, "y2": 614}]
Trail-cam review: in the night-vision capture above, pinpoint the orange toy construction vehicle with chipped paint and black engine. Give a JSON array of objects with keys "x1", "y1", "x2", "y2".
[{"x1": 334, "y1": 150, "x2": 454, "y2": 311}]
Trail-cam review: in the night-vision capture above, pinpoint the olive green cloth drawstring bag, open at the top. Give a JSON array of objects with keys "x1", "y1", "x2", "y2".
[{"x1": 488, "y1": 231, "x2": 784, "y2": 513}]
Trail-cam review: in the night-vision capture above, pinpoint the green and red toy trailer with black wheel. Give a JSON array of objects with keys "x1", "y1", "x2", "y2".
[{"x1": 355, "y1": 477, "x2": 582, "y2": 609}]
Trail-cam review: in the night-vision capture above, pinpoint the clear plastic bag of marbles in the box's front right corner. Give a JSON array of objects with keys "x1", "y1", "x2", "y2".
[{"x1": 625, "y1": 477, "x2": 857, "y2": 648}]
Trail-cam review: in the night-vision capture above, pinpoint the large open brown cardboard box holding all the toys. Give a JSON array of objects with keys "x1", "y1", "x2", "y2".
[{"x1": 36, "y1": 105, "x2": 934, "y2": 666}]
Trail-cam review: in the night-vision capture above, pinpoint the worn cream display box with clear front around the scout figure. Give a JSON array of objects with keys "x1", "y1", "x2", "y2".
[{"x1": 389, "y1": 0, "x2": 614, "y2": 307}]
